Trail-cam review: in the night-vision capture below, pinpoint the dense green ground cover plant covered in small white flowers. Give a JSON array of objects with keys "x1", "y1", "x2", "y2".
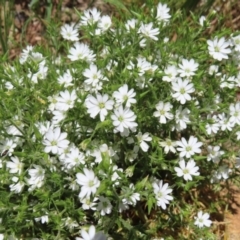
[{"x1": 0, "y1": 0, "x2": 240, "y2": 240}]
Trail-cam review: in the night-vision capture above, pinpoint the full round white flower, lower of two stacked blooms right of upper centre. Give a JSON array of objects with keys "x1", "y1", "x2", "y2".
[{"x1": 172, "y1": 78, "x2": 195, "y2": 104}]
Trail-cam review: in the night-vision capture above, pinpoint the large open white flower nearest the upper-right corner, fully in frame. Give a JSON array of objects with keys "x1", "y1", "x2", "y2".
[{"x1": 207, "y1": 37, "x2": 231, "y2": 61}]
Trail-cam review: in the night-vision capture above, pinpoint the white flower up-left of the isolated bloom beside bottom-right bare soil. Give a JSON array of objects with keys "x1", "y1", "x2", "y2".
[{"x1": 152, "y1": 180, "x2": 173, "y2": 209}]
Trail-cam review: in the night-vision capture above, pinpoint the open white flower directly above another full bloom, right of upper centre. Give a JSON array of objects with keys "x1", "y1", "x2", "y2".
[{"x1": 178, "y1": 59, "x2": 199, "y2": 78}]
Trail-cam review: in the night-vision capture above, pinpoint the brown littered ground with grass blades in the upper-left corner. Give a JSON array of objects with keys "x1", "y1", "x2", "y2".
[{"x1": 0, "y1": 0, "x2": 113, "y2": 59}]
